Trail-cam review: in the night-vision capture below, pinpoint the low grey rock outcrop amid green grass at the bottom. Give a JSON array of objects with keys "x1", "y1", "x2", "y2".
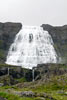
[{"x1": 5, "y1": 89, "x2": 55, "y2": 100}]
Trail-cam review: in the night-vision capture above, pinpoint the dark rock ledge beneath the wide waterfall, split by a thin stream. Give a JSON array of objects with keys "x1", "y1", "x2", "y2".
[{"x1": 0, "y1": 64, "x2": 67, "y2": 84}]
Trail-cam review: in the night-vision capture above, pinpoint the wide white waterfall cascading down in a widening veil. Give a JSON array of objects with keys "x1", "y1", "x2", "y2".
[{"x1": 6, "y1": 26, "x2": 57, "y2": 69}]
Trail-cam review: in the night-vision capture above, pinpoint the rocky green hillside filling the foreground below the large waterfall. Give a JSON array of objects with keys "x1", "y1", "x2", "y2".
[{"x1": 0, "y1": 64, "x2": 67, "y2": 100}]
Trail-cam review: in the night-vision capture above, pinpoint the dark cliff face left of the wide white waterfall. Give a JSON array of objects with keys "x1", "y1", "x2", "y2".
[{"x1": 0, "y1": 22, "x2": 22, "y2": 63}]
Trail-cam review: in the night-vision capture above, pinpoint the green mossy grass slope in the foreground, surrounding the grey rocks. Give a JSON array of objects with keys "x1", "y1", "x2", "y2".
[{"x1": 0, "y1": 74, "x2": 67, "y2": 100}]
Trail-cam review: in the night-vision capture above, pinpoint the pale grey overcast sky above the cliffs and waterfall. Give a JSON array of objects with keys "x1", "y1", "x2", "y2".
[{"x1": 0, "y1": 0, "x2": 67, "y2": 26}]
